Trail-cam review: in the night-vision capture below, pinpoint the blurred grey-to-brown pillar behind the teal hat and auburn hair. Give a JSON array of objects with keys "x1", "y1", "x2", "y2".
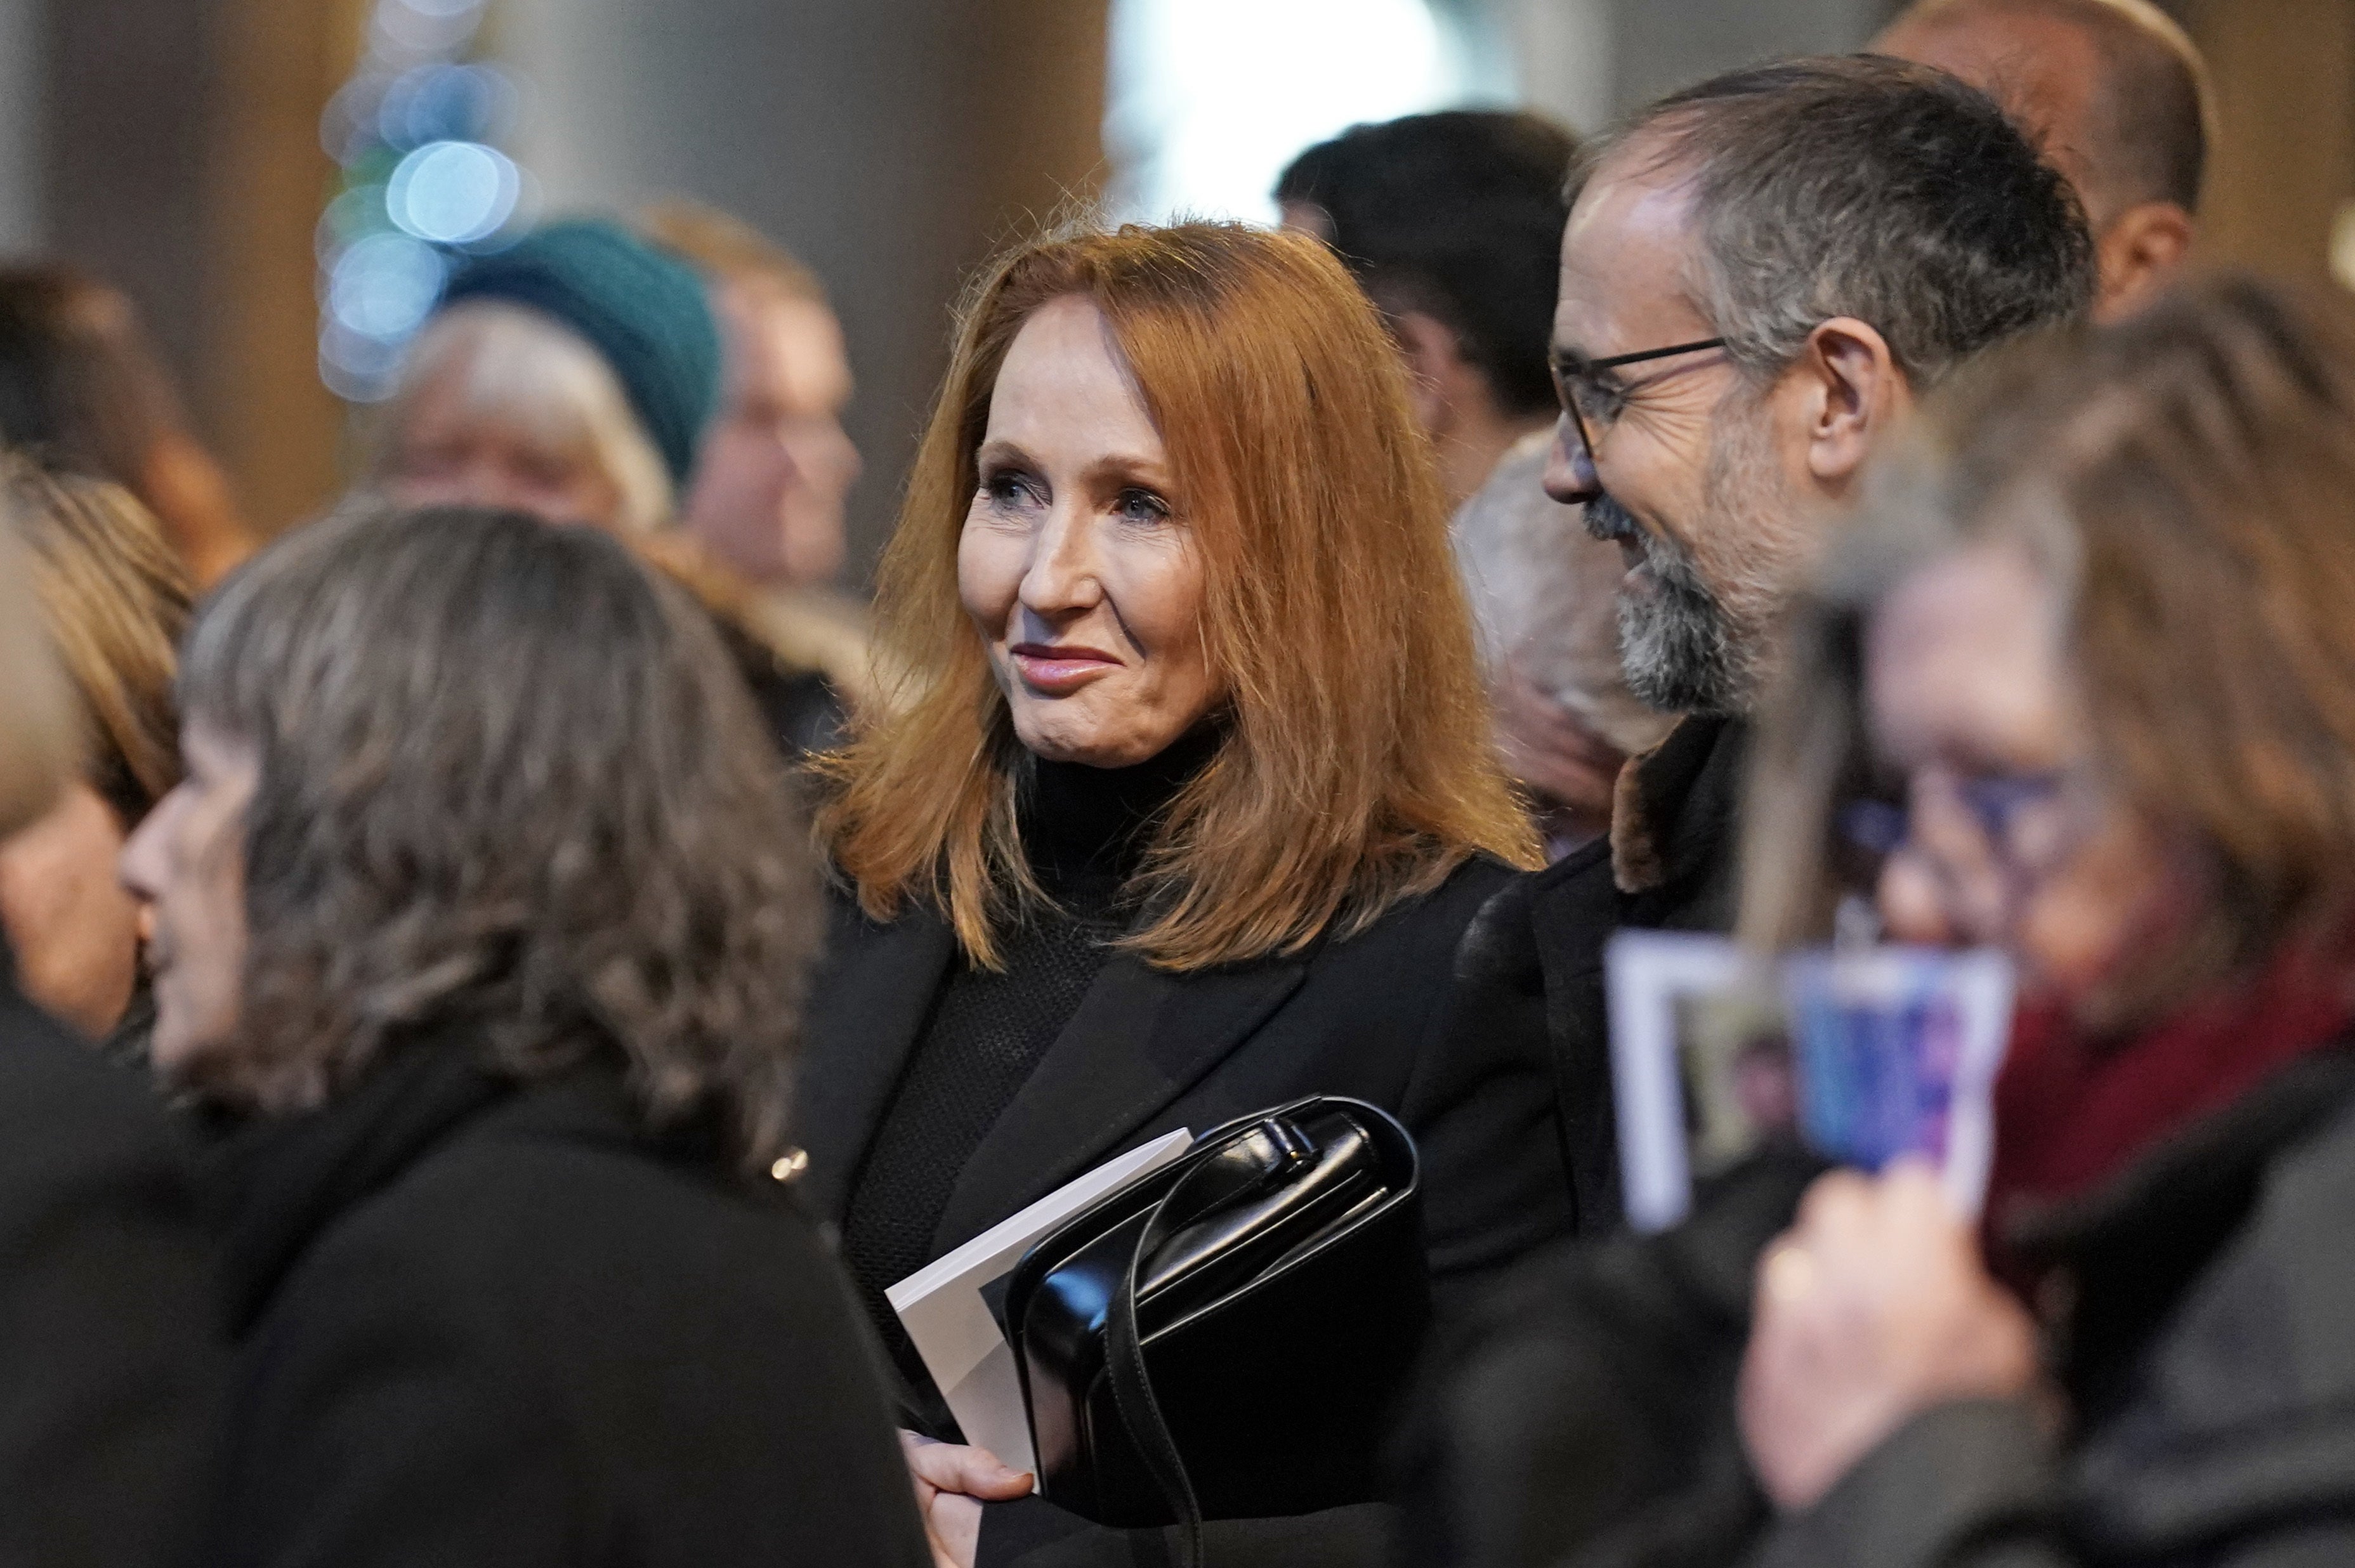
[{"x1": 492, "y1": 0, "x2": 1107, "y2": 577}]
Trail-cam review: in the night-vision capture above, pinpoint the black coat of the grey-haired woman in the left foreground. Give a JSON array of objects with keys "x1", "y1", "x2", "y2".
[{"x1": 205, "y1": 1038, "x2": 930, "y2": 1568}]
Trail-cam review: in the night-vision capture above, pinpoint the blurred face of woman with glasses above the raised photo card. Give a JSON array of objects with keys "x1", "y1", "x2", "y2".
[{"x1": 1865, "y1": 544, "x2": 2202, "y2": 1012}]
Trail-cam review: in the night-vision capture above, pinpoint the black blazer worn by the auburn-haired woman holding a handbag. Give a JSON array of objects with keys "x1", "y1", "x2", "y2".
[{"x1": 798, "y1": 861, "x2": 1571, "y2": 1561}]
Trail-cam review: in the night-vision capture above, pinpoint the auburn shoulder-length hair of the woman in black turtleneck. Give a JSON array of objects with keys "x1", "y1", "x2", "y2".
[{"x1": 820, "y1": 224, "x2": 1535, "y2": 970}]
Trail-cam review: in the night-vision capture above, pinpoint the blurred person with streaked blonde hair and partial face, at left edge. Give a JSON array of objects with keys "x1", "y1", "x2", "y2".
[{"x1": 0, "y1": 459, "x2": 188, "y2": 1069}]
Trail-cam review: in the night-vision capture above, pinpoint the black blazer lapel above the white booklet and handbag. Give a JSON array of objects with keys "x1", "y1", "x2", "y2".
[{"x1": 933, "y1": 953, "x2": 1309, "y2": 1253}]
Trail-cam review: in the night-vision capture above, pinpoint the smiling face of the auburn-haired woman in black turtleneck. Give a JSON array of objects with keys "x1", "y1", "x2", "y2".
[{"x1": 956, "y1": 297, "x2": 1223, "y2": 768}]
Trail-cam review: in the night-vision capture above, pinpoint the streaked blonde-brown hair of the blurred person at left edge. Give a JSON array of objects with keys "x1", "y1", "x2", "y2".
[{"x1": 0, "y1": 459, "x2": 193, "y2": 829}]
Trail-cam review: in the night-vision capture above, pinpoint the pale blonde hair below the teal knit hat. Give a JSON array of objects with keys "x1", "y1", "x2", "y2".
[{"x1": 370, "y1": 299, "x2": 676, "y2": 532}]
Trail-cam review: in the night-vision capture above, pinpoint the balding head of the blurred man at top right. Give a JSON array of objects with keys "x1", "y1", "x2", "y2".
[{"x1": 1872, "y1": 0, "x2": 2216, "y2": 318}]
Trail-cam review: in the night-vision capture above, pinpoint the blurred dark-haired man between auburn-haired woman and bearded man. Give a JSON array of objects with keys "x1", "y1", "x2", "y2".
[{"x1": 1276, "y1": 110, "x2": 1667, "y2": 857}]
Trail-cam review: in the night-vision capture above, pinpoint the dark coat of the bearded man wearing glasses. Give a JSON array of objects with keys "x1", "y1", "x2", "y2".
[{"x1": 1453, "y1": 718, "x2": 1750, "y2": 1236}]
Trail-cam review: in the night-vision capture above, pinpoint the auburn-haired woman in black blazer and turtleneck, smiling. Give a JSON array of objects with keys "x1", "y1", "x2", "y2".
[{"x1": 801, "y1": 224, "x2": 1571, "y2": 1561}]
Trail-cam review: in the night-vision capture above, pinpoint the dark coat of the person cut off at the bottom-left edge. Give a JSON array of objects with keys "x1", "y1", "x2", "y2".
[{"x1": 0, "y1": 944, "x2": 224, "y2": 1568}]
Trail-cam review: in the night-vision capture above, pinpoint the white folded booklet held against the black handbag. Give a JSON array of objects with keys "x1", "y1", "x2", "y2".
[{"x1": 883, "y1": 1128, "x2": 1194, "y2": 1472}]
